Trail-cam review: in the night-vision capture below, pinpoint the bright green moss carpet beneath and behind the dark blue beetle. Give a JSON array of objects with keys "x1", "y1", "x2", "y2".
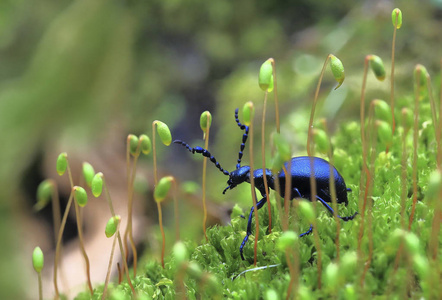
[{"x1": 77, "y1": 92, "x2": 442, "y2": 299}]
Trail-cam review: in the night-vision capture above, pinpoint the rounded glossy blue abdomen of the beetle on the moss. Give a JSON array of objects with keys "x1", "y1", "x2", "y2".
[{"x1": 278, "y1": 156, "x2": 348, "y2": 205}]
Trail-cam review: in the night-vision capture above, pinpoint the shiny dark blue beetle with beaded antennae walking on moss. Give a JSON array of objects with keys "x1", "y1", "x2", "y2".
[{"x1": 174, "y1": 109, "x2": 358, "y2": 260}]
